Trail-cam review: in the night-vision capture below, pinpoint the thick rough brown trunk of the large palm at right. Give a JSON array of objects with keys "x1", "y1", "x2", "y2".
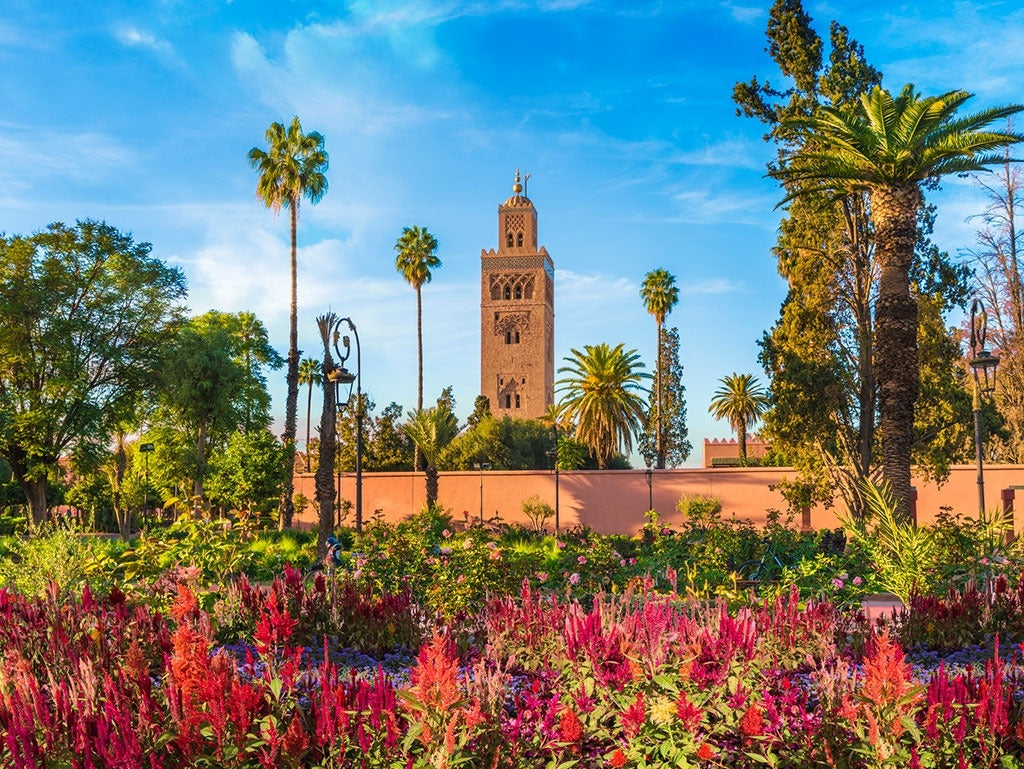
[{"x1": 871, "y1": 184, "x2": 921, "y2": 515}]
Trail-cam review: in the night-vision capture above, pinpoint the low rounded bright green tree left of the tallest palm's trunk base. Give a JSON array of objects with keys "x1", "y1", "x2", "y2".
[{"x1": 208, "y1": 429, "x2": 286, "y2": 513}]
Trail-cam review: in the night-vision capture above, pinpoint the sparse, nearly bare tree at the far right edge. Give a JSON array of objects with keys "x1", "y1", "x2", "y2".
[{"x1": 968, "y1": 155, "x2": 1024, "y2": 464}]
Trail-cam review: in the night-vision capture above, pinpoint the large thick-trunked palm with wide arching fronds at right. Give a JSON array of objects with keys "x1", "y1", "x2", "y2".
[{"x1": 772, "y1": 84, "x2": 1024, "y2": 513}]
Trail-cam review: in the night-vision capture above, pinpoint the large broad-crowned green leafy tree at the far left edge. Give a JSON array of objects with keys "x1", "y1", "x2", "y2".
[{"x1": 0, "y1": 220, "x2": 185, "y2": 523}]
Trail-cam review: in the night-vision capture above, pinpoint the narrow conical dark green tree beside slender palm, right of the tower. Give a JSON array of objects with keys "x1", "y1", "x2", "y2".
[{"x1": 640, "y1": 329, "x2": 693, "y2": 469}]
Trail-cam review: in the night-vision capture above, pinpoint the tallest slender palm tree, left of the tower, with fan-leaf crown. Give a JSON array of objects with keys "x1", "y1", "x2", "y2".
[{"x1": 248, "y1": 117, "x2": 328, "y2": 526}]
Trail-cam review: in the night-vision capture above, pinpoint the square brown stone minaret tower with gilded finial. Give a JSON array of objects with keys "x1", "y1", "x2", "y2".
[{"x1": 480, "y1": 170, "x2": 555, "y2": 419}]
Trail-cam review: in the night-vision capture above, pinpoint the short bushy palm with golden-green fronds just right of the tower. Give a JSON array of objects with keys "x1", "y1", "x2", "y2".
[{"x1": 557, "y1": 342, "x2": 650, "y2": 470}]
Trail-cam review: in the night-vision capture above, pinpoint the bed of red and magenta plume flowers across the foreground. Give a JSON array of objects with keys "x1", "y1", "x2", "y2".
[{"x1": 0, "y1": 571, "x2": 1024, "y2": 769}]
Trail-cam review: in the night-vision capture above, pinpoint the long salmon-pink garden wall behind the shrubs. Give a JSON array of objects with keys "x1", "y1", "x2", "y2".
[{"x1": 286, "y1": 465, "x2": 1024, "y2": 533}]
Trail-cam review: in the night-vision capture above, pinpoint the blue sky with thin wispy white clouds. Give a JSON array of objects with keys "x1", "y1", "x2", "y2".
[{"x1": 0, "y1": 0, "x2": 1024, "y2": 465}]
